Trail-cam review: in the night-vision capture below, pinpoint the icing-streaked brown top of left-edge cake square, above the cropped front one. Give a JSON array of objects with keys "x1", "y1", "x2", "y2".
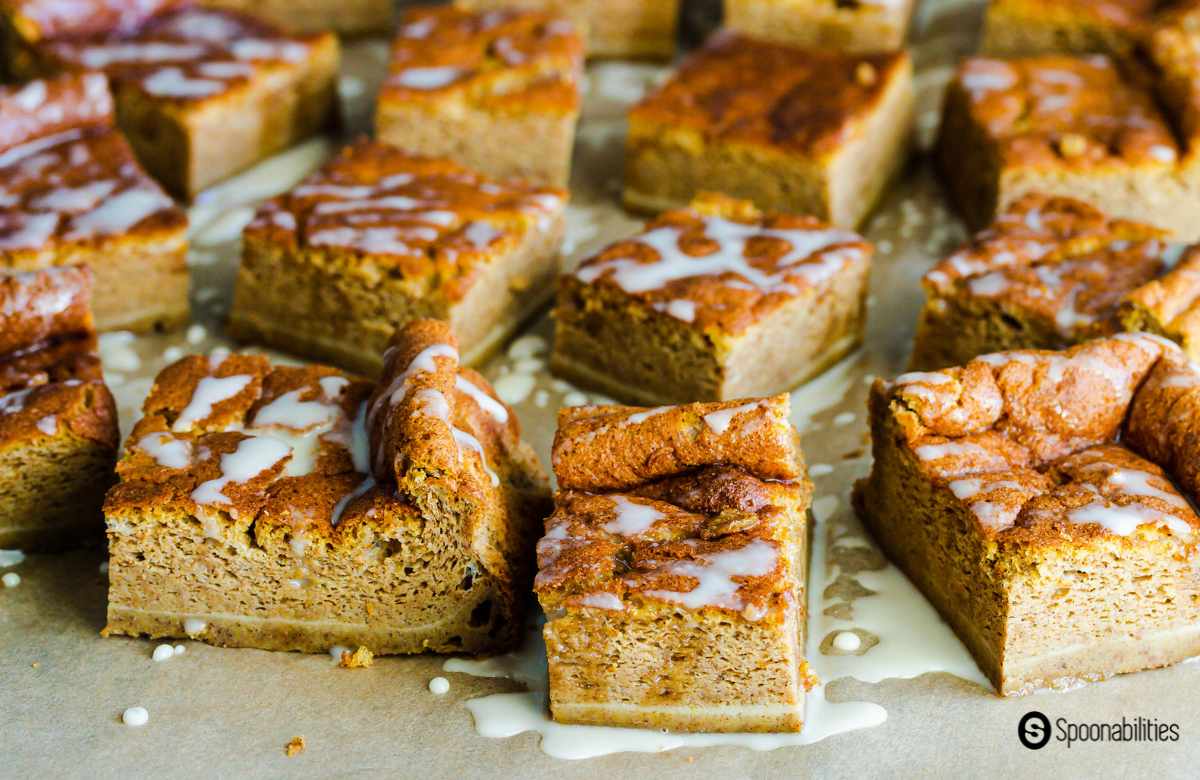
[{"x1": 0, "y1": 74, "x2": 187, "y2": 252}]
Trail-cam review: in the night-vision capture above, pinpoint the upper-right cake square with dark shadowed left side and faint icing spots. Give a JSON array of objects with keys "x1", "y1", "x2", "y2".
[{"x1": 936, "y1": 54, "x2": 1200, "y2": 234}]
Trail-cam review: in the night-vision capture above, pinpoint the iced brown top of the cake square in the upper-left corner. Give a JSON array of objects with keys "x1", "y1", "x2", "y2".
[{"x1": 38, "y1": 7, "x2": 332, "y2": 103}]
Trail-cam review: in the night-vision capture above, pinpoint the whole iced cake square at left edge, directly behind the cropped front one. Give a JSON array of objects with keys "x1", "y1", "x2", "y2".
[{"x1": 0, "y1": 73, "x2": 188, "y2": 331}]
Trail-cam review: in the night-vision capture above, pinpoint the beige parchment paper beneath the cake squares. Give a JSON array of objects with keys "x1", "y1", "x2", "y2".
[{"x1": 0, "y1": 2, "x2": 1200, "y2": 780}]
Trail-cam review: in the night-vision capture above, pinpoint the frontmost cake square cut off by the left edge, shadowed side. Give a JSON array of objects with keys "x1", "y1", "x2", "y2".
[{"x1": 0, "y1": 266, "x2": 120, "y2": 550}]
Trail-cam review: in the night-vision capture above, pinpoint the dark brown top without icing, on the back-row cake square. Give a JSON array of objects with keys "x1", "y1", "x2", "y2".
[{"x1": 630, "y1": 34, "x2": 910, "y2": 157}]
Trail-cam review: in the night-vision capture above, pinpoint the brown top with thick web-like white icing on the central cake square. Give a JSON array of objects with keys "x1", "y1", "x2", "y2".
[{"x1": 575, "y1": 196, "x2": 872, "y2": 334}]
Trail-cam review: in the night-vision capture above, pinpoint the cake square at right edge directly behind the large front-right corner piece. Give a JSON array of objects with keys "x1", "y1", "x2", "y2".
[{"x1": 911, "y1": 194, "x2": 1200, "y2": 370}]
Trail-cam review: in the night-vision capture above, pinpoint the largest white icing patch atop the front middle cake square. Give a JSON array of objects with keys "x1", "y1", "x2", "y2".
[{"x1": 646, "y1": 539, "x2": 779, "y2": 611}]
